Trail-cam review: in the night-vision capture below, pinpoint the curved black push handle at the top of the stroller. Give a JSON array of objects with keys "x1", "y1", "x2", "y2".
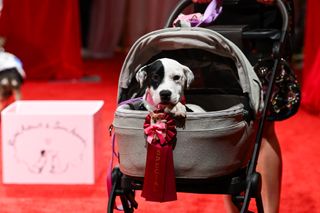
[{"x1": 165, "y1": 0, "x2": 289, "y2": 42}]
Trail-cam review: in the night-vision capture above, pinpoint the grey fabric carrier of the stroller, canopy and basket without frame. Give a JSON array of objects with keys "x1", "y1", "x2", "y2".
[{"x1": 113, "y1": 28, "x2": 263, "y2": 179}]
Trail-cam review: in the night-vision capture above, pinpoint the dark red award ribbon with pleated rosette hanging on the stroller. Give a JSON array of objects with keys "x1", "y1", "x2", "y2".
[{"x1": 142, "y1": 110, "x2": 177, "y2": 202}]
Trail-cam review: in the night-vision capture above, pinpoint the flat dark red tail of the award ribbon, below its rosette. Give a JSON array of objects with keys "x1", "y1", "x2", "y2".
[{"x1": 142, "y1": 144, "x2": 177, "y2": 202}]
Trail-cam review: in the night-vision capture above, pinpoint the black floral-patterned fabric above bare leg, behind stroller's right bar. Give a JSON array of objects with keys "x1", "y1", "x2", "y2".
[{"x1": 254, "y1": 58, "x2": 301, "y2": 121}]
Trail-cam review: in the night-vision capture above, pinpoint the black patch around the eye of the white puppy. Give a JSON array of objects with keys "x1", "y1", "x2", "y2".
[{"x1": 145, "y1": 60, "x2": 164, "y2": 89}]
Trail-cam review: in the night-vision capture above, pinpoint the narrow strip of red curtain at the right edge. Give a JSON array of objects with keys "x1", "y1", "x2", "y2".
[{"x1": 302, "y1": 0, "x2": 320, "y2": 113}]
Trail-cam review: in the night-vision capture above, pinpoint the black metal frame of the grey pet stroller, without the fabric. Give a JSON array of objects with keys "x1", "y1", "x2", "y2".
[{"x1": 107, "y1": 0, "x2": 289, "y2": 213}]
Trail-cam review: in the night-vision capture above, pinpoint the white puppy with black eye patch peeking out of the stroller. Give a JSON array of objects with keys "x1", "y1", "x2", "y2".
[{"x1": 136, "y1": 58, "x2": 194, "y2": 117}]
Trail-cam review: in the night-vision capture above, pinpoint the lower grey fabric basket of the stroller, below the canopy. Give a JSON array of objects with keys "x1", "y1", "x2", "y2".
[{"x1": 114, "y1": 105, "x2": 253, "y2": 179}]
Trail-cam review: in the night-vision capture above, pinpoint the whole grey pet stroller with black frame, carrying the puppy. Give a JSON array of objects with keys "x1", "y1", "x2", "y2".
[{"x1": 108, "y1": 0, "x2": 296, "y2": 212}]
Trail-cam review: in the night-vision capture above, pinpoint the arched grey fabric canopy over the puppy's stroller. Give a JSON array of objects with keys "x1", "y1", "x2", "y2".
[{"x1": 118, "y1": 27, "x2": 263, "y2": 114}]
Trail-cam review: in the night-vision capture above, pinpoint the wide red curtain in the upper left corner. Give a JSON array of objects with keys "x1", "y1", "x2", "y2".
[{"x1": 0, "y1": 0, "x2": 83, "y2": 80}]
